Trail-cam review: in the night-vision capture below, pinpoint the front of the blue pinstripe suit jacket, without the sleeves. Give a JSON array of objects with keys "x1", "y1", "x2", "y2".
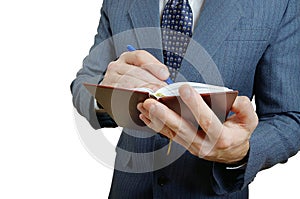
[{"x1": 81, "y1": 0, "x2": 298, "y2": 198}]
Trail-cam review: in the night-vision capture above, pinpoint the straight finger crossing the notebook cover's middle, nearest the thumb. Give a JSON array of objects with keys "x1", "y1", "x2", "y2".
[{"x1": 179, "y1": 85, "x2": 223, "y2": 140}]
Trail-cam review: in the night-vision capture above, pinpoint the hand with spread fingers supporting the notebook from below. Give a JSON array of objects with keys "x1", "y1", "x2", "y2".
[{"x1": 138, "y1": 85, "x2": 258, "y2": 164}]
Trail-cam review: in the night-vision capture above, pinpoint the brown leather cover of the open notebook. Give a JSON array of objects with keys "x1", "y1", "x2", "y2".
[{"x1": 84, "y1": 83, "x2": 238, "y2": 129}]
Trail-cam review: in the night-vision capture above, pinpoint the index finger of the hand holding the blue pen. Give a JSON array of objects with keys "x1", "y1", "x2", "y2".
[{"x1": 119, "y1": 50, "x2": 170, "y2": 80}]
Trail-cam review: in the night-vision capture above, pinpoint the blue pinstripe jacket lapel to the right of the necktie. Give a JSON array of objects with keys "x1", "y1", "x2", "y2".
[{"x1": 177, "y1": 0, "x2": 243, "y2": 85}]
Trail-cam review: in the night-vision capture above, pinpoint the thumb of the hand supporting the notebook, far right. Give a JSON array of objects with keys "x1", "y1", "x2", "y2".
[{"x1": 231, "y1": 96, "x2": 258, "y2": 131}]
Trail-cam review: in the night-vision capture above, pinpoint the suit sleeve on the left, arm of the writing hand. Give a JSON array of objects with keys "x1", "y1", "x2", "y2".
[{"x1": 71, "y1": 0, "x2": 117, "y2": 129}]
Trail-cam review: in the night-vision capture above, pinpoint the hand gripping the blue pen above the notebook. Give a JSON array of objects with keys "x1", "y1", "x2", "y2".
[{"x1": 100, "y1": 50, "x2": 170, "y2": 91}]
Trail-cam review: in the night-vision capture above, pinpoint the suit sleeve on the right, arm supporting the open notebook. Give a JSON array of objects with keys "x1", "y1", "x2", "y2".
[{"x1": 213, "y1": 0, "x2": 300, "y2": 194}]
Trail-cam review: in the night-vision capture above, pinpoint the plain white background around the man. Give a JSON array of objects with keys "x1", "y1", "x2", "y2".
[{"x1": 0, "y1": 0, "x2": 300, "y2": 199}]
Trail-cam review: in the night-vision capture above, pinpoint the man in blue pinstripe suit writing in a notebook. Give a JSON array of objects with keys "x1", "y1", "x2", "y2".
[{"x1": 71, "y1": 0, "x2": 300, "y2": 198}]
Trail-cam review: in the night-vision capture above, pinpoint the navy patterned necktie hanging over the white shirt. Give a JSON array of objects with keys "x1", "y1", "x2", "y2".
[{"x1": 161, "y1": 0, "x2": 193, "y2": 80}]
